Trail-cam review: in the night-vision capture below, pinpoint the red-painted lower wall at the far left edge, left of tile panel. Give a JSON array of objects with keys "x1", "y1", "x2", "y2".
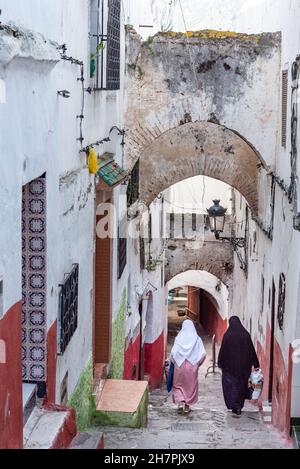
[{"x1": 0, "y1": 302, "x2": 23, "y2": 449}]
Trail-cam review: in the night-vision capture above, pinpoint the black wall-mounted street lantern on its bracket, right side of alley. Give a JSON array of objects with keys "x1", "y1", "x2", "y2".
[{"x1": 207, "y1": 200, "x2": 247, "y2": 272}]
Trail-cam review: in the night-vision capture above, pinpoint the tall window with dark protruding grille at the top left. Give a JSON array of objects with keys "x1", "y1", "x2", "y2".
[{"x1": 90, "y1": 0, "x2": 121, "y2": 90}]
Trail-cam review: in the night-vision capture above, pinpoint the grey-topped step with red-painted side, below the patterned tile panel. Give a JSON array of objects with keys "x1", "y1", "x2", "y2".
[{"x1": 24, "y1": 406, "x2": 77, "y2": 449}]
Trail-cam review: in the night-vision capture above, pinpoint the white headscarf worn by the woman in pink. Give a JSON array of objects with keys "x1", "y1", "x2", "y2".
[{"x1": 171, "y1": 320, "x2": 206, "y2": 367}]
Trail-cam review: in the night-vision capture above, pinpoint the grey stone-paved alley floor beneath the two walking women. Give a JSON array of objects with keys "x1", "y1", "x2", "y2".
[{"x1": 97, "y1": 316, "x2": 291, "y2": 450}]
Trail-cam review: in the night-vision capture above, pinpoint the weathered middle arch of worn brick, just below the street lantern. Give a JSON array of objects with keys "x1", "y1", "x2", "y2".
[{"x1": 165, "y1": 240, "x2": 234, "y2": 287}]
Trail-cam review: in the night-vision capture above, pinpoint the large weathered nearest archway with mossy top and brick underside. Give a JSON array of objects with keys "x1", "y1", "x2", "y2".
[{"x1": 125, "y1": 27, "x2": 281, "y2": 215}]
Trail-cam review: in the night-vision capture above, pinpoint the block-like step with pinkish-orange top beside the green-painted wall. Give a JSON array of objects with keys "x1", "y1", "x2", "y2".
[{"x1": 95, "y1": 379, "x2": 149, "y2": 428}]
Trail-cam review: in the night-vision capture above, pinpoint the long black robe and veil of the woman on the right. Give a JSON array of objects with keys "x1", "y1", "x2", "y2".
[{"x1": 218, "y1": 316, "x2": 259, "y2": 411}]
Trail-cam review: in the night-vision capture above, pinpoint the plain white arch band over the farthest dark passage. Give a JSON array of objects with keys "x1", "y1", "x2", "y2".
[{"x1": 168, "y1": 270, "x2": 229, "y2": 319}]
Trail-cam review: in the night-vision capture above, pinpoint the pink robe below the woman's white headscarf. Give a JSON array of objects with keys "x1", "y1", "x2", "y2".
[{"x1": 172, "y1": 360, "x2": 203, "y2": 405}]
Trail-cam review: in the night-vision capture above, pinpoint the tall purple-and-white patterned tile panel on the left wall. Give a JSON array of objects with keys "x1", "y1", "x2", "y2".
[{"x1": 22, "y1": 178, "x2": 47, "y2": 382}]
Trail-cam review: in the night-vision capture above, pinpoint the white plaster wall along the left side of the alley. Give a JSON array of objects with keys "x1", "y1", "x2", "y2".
[{"x1": 0, "y1": 0, "x2": 127, "y2": 402}]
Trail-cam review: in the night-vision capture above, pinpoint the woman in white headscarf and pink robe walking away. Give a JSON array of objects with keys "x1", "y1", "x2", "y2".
[{"x1": 170, "y1": 320, "x2": 206, "y2": 414}]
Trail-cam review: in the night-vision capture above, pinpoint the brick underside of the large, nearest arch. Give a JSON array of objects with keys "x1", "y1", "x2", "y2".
[{"x1": 132, "y1": 121, "x2": 265, "y2": 214}]
